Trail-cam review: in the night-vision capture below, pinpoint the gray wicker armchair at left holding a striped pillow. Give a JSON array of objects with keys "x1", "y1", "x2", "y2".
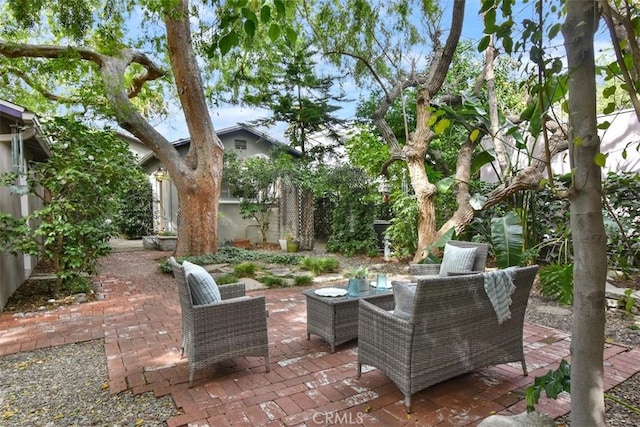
[{"x1": 169, "y1": 257, "x2": 269, "y2": 387}]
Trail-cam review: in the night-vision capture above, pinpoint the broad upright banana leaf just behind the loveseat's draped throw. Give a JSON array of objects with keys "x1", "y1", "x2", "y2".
[{"x1": 491, "y1": 212, "x2": 524, "y2": 268}]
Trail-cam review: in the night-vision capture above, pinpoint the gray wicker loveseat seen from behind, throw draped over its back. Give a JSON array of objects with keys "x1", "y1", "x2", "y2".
[{"x1": 358, "y1": 266, "x2": 538, "y2": 413}]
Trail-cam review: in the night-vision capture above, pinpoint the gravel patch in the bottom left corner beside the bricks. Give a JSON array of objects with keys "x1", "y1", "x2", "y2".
[{"x1": 0, "y1": 340, "x2": 178, "y2": 427}]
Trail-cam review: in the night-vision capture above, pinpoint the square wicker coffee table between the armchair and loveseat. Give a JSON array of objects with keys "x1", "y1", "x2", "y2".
[{"x1": 302, "y1": 286, "x2": 395, "y2": 353}]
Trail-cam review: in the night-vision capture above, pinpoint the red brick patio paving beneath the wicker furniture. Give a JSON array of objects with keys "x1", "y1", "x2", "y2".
[{"x1": 0, "y1": 251, "x2": 640, "y2": 427}]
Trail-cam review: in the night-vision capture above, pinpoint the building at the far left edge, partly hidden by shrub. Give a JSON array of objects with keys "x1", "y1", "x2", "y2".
[{"x1": 0, "y1": 100, "x2": 50, "y2": 311}]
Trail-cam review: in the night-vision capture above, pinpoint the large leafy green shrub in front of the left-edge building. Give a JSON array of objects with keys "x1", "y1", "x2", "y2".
[{"x1": 0, "y1": 118, "x2": 135, "y2": 295}]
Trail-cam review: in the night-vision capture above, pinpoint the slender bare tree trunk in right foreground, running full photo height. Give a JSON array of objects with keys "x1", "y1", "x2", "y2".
[{"x1": 562, "y1": 1, "x2": 607, "y2": 426}]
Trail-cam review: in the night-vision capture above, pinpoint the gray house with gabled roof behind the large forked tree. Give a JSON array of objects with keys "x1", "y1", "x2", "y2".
[{"x1": 140, "y1": 124, "x2": 300, "y2": 244}]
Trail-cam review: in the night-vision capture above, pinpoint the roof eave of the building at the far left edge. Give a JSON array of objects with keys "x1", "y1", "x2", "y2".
[{"x1": 0, "y1": 99, "x2": 51, "y2": 161}]
